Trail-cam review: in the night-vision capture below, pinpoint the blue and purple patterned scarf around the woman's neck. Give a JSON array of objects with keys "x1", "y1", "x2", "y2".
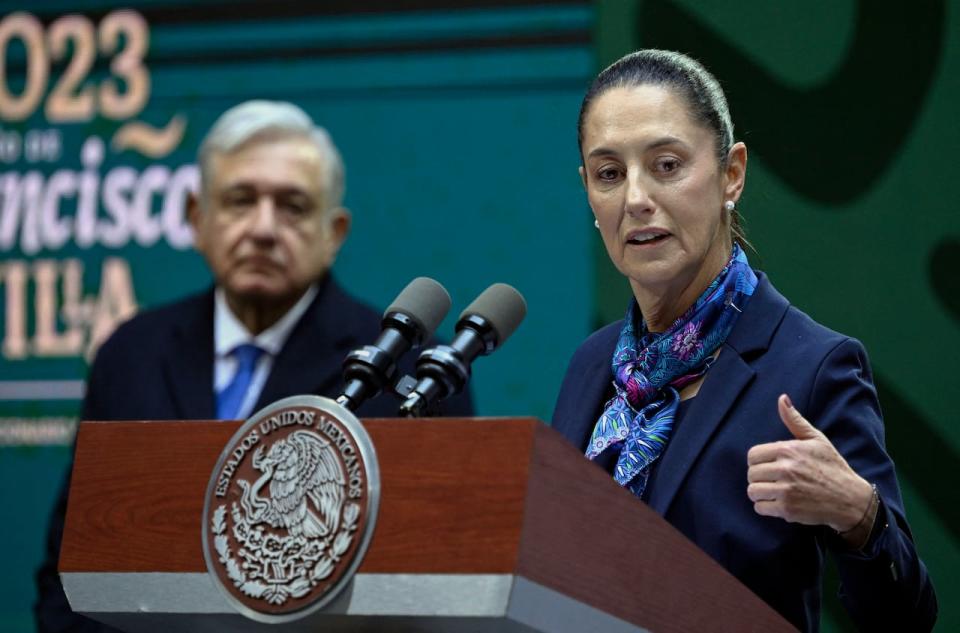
[{"x1": 586, "y1": 245, "x2": 757, "y2": 497}]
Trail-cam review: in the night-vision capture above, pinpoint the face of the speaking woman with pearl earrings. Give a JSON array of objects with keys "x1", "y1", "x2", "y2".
[{"x1": 580, "y1": 85, "x2": 746, "y2": 303}]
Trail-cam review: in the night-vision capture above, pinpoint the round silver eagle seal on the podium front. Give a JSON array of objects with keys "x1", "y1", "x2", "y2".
[{"x1": 202, "y1": 396, "x2": 380, "y2": 623}]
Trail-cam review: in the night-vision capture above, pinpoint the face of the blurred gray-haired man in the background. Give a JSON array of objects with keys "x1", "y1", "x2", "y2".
[{"x1": 190, "y1": 138, "x2": 350, "y2": 310}]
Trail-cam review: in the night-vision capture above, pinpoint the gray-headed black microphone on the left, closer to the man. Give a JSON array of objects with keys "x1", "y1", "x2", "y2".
[{"x1": 337, "y1": 277, "x2": 450, "y2": 411}]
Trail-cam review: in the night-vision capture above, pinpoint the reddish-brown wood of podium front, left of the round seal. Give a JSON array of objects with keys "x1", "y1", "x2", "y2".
[{"x1": 60, "y1": 421, "x2": 240, "y2": 572}]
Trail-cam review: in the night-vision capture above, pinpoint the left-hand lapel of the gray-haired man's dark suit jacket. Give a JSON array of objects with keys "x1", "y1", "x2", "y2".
[{"x1": 163, "y1": 290, "x2": 216, "y2": 420}]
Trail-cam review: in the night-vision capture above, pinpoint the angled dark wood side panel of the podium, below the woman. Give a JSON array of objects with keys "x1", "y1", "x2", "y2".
[{"x1": 518, "y1": 426, "x2": 795, "y2": 633}]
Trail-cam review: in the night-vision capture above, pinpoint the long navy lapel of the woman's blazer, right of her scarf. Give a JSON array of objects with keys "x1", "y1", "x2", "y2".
[{"x1": 648, "y1": 273, "x2": 790, "y2": 516}]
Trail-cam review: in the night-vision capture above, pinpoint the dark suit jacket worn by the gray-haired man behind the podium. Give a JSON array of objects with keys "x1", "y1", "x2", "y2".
[{"x1": 34, "y1": 275, "x2": 473, "y2": 632}]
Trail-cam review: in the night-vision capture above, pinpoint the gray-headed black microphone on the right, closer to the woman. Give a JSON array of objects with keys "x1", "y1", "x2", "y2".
[{"x1": 400, "y1": 284, "x2": 527, "y2": 417}]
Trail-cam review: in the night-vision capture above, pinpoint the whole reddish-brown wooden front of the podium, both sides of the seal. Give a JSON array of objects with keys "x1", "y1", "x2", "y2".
[{"x1": 60, "y1": 418, "x2": 541, "y2": 573}]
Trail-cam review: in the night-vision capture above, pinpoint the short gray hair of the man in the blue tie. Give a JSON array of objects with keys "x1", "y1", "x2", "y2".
[{"x1": 198, "y1": 100, "x2": 345, "y2": 209}]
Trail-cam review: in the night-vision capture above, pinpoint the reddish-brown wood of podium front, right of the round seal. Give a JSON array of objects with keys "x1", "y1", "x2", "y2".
[{"x1": 359, "y1": 418, "x2": 541, "y2": 573}]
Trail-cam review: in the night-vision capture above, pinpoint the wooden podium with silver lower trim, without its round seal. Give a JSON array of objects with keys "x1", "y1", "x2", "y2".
[{"x1": 60, "y1": 418, "x2": 794, "y2": 633}]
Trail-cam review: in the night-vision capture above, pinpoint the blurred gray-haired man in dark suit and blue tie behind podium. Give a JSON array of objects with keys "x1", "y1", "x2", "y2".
[{"x1": 35, "y1": 101, "x2": 472, "y2": 631}]
